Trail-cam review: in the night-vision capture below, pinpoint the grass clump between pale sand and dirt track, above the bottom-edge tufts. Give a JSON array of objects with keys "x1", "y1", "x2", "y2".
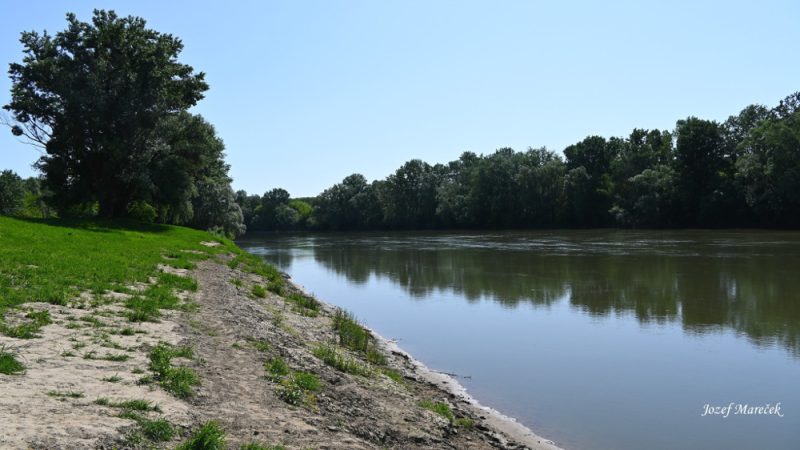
[{"x1": 149, "y1": 342, "x2": 200, "y2": 398}]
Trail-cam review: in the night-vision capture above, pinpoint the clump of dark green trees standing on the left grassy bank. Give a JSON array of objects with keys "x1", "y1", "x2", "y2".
[{"x1": 0, "y1": 10, "x2": 244, "y2": 236}]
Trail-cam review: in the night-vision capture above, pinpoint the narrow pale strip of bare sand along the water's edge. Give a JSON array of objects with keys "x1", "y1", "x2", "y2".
[{"x1": 283, "y1": 278, "x2": 565, "y2": 450}]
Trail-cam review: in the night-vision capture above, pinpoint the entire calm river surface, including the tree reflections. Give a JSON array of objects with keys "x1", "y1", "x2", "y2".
[{"x1": 240, "y1": 231, "x2": 800, "y2": 450}]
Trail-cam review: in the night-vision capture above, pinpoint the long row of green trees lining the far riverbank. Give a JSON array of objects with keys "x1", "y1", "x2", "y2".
[{"x1": 241, "y1": 93, "x2": 800, "y2": 230}]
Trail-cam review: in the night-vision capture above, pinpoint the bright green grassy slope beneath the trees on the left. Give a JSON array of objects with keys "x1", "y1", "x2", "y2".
[{"x1": 0, "y1": 217, "x2": 230, "y2": 314}]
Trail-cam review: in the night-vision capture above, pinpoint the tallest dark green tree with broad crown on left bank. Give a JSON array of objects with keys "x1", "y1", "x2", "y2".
[{"x1": 4, "y1": 10, "x2": 208, "y2": 217}]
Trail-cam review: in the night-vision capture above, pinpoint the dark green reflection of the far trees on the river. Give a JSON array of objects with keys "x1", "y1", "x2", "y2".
[{"x1": 241, "y1": 231, "x2": 800, "y2": 357}]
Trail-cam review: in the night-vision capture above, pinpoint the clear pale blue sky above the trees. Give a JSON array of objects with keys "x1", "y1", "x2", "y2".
[{"x1": 0, "y1": 0, "x2": 800, "y2": 197}]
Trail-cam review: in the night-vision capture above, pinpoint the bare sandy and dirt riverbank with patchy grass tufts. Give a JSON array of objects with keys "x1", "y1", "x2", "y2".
[{"x1": 0, "y1": 253, "x2": 557, "y2": 450}]
